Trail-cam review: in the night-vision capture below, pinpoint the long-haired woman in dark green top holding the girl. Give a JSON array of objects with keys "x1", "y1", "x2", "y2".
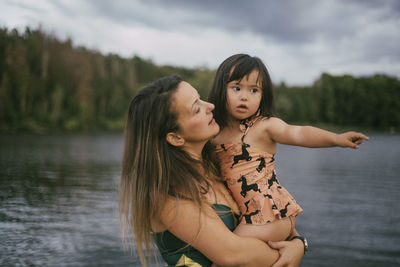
[{"x1": 120, "y1": 76, "x2": 304, "y2": 266}]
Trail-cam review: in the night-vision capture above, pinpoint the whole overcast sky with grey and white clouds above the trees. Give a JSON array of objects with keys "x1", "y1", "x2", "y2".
[{"x1": 0, "y1": 0, "x2": 400, "y2": 85}]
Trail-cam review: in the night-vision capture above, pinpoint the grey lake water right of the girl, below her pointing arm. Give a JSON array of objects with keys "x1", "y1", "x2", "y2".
[{"x1": 277, "y1": 135, "x2": 400, "y2": 266}]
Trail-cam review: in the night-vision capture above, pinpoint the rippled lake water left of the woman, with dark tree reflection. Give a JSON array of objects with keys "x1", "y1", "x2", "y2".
[{"x1": 0, "y1": 135, "x2": 143, "y2": 266}]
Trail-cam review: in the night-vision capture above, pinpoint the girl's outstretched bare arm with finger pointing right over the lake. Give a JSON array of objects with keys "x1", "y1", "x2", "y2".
[{"x1": 265, "y1": 118, "x2": 369, "y2": 148}]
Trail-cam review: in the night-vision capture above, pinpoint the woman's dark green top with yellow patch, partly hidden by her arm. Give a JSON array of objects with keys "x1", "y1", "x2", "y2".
[{"x1": 153, "y1": 204, "x2": 238, "y2": 267}]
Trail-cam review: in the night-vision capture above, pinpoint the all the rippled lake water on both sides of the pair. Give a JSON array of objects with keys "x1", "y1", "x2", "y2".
[{"x1": 0, "y1": 134, "x2": 400, "y2": 266}]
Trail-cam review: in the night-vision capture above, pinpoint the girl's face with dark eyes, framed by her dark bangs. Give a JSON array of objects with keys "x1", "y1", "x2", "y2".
[{"x1": 226, "y1": 70, "x2": 262, "y2": 120}]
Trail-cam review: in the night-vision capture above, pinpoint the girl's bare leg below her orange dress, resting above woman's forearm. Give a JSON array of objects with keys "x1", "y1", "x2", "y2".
[{"x1": 233, "y1": 216, "x2": 296, "y2": 242}]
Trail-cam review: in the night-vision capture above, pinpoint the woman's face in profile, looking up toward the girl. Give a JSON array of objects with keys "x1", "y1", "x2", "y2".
[{"x1": 172, "y1": 81, "x2": 219, "y2": 146}]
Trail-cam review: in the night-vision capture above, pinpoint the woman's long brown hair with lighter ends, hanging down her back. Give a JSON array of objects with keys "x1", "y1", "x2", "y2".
[{"x1": 119, "y1": 76, "x2": 217, "y2": 266}]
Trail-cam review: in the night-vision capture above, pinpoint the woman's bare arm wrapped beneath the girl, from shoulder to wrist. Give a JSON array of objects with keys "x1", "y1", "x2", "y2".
[{"x1": 161, "y1": 199, "x2": 279, "y2": 266}]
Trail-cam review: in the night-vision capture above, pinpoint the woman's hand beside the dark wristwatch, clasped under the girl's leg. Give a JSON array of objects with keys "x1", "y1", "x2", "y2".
[{"x1": 268, "y1": 239, "x2": 304, "y2": 267}]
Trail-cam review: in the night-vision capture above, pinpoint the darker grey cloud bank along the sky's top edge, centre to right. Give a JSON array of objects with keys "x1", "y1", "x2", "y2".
[{"x1": 142, "y1": 0, "x2": 400, "y2": 43}]
